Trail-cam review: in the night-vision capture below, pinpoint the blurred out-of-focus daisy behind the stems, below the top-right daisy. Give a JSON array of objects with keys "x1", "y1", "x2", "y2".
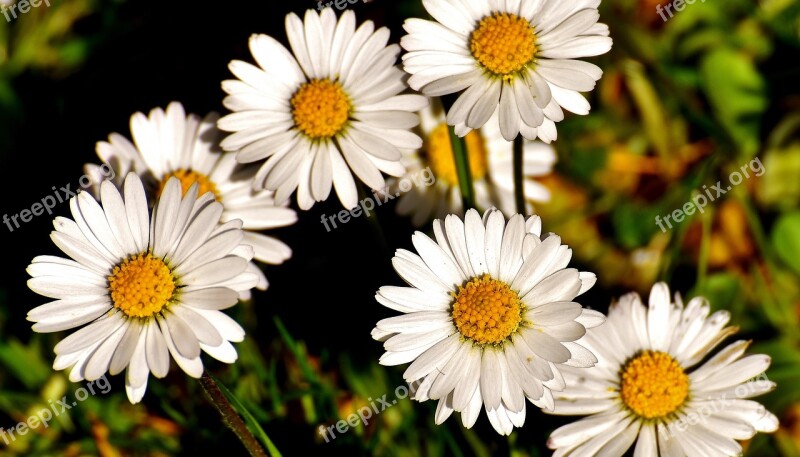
[{"x1": 390, "y1": 101, "x2": 556, "y2": 227}]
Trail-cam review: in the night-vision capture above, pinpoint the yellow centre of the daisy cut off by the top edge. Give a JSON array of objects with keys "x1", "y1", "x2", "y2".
[{"x1": 469, "y1": 13, "x2": 536, "y2": 77}]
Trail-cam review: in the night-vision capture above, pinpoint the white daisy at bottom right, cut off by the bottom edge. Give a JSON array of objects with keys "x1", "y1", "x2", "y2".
[{"x1": 548, "y1": 283, "x2": 778, "y2": 457}]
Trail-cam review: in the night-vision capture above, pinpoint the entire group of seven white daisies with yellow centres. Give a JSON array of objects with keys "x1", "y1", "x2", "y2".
[{"x1": 23, "y1": 0, "x2": 777, "y2": 456}]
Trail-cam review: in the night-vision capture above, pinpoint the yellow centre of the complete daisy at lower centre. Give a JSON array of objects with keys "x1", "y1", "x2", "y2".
[{"x1": 452, "y1": 275, "x2": 524, "y2": 345}]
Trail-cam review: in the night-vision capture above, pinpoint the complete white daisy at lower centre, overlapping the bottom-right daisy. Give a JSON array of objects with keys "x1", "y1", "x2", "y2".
[{"x1": 372, "y1": 209, "x2": 604, "y2": 435}]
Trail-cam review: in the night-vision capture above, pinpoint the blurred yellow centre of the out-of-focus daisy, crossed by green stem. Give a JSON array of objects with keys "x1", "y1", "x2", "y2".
[{"x1": 425, "y1": 123, "x2": 487, "y2": 186}]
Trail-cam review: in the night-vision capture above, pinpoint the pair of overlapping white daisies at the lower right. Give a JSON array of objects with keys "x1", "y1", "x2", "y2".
[{"x1": 372, "y1": 209, "x2": 778, "y2": 457}]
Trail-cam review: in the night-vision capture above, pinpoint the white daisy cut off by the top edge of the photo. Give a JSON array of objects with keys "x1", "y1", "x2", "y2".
[{"x1": 401, "y1": 0, "x2": 611, "y2": 143}]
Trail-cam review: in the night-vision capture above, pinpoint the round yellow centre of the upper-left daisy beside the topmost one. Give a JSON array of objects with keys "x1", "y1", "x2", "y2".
[{"x1": 291, "y1": 79, "x2": 353, "y2": 139}]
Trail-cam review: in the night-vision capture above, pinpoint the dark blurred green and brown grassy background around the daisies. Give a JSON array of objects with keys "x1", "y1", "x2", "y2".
[{"x1": 0, "y1": 0, "x2": 800, "y2": 457}]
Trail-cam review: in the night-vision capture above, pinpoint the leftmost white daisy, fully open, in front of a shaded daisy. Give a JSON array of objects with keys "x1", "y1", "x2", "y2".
[{"x1": 28, "y1": 173, "x2": 258, "y2": 403}]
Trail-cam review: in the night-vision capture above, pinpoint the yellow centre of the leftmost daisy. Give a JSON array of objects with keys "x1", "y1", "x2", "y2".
[{"x1": 108, "y1": 253, "x2": 176, "y2": 317}]
